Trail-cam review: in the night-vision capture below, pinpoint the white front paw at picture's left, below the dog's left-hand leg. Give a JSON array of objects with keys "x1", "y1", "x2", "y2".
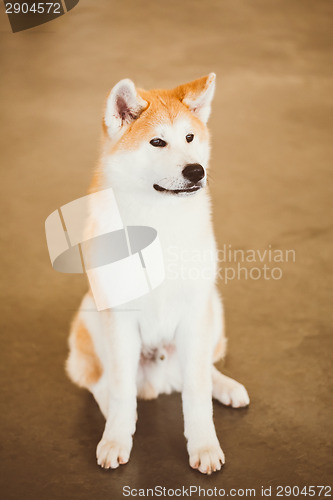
[{"x1": 96, "y1": 437, "x2": 132, "y2": 469}]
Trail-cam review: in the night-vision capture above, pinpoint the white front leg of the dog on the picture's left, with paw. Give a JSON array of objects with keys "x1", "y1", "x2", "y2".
[{"x1": 96, "y1": 311, "x2": 141, "y2": 469}]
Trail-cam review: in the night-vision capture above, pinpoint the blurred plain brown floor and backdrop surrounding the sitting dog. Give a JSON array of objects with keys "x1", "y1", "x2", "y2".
[{"x1": 0, "y1": 0, "x2": 333, "y2": 500}]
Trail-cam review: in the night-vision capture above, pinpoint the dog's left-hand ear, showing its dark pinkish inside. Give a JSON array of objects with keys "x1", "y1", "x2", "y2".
[{"x1": 104, "y1": 78, "x2": 148, "y2": 137}]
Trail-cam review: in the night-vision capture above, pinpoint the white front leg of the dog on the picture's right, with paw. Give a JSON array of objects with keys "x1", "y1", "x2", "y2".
[{"x1": 177, "y1": 306, "x2": 224, "y2": 474}]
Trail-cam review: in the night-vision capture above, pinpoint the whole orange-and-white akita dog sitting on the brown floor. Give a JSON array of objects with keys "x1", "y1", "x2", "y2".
[{"x1": 67, "y1": 73, "x2": 249, "y2": 474}]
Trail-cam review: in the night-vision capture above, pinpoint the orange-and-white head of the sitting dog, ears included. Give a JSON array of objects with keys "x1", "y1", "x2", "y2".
[{"x1": 103, "y1": 73, "x2": 215, "y2": 197}]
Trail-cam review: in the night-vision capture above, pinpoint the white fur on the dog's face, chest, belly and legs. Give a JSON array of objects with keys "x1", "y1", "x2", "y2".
[{"x1": 68, "y1": 76, "x2": 249, "y2": 473}]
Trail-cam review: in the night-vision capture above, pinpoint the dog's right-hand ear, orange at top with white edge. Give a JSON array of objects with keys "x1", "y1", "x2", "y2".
[{"x1": 175, "y1": 73, "x2": 216, "y2": 124}]
